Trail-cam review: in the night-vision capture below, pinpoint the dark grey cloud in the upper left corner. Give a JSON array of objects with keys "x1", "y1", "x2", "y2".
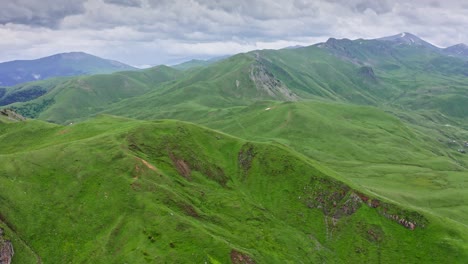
[{"x1": 0, "y1": 0, "x2": 85, "y2": 28}]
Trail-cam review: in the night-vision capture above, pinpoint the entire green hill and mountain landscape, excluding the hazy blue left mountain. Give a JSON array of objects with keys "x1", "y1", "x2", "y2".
[{"x1": 0, "y1": 33, "x2": 468, "y2": 263}]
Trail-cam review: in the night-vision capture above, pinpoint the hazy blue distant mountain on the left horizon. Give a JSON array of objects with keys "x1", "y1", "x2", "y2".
[{"x1": 0, "y1": 52, "x2": 136, "y2": 86}]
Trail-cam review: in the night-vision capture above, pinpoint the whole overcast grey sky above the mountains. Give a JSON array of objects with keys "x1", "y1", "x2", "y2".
[{"x1": 0, "y1": 0, "x2": 468, "y2": 66}]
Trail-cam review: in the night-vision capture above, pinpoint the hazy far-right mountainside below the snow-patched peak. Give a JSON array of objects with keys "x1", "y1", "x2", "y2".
[{"x1": 317, "y1": 35, "x2": 468, "y2": 118}]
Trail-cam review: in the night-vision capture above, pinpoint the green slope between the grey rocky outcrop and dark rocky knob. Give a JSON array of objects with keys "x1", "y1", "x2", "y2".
[{"x1": 252, "y1": 46, "x2": 390, "y2": 104}]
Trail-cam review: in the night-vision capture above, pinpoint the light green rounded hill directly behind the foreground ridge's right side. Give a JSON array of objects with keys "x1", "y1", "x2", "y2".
[{"x1": 206, "y1": 101, "x2": 468, "y2": 228}]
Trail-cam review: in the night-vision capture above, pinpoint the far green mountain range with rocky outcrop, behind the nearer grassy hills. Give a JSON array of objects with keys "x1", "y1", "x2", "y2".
[{"x1": 5, "y1": 33, "x2": 468, "y2": 123}]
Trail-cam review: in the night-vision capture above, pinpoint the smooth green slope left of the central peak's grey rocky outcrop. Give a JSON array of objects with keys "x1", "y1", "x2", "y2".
[{"x1": 105, "y1": 54, "x2": 272, "y2": 120}]
